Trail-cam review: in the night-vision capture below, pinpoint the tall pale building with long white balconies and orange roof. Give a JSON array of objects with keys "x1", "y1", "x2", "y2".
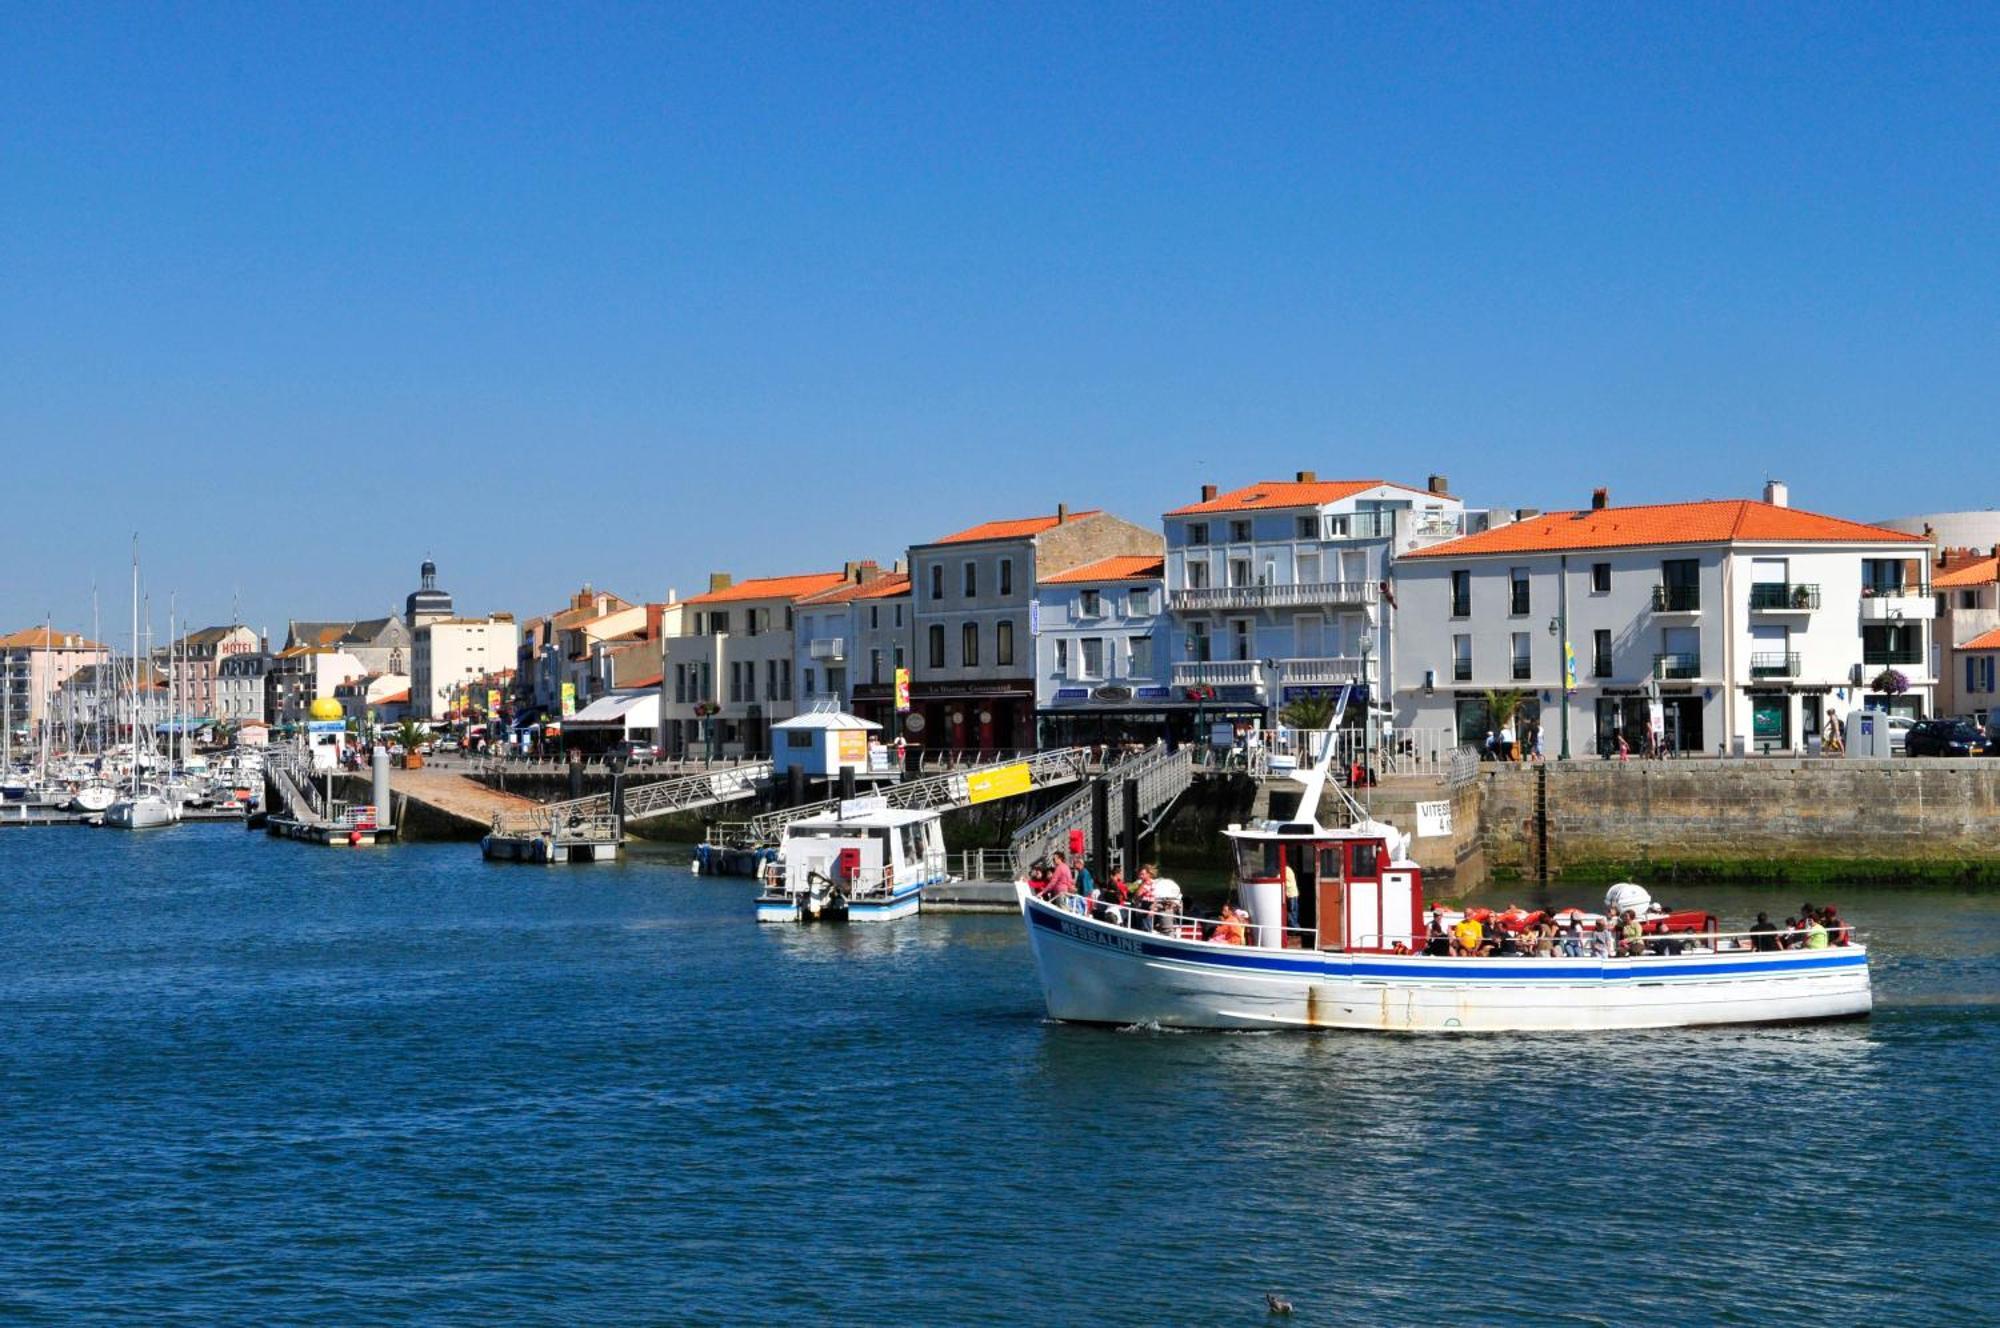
[{"x1": 1164, "y1": 470, "x2": 1486, "y2": 732}]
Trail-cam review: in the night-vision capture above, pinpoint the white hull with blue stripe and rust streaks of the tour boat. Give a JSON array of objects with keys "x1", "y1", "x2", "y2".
[{"x1": 1016, "y1": 886, "x2": 1872, "y2": 1032}]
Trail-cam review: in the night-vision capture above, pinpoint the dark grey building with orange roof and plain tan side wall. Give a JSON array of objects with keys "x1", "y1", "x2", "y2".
[{"x1": 904, "y1": 504, "x2": 1160, "y2": 750}]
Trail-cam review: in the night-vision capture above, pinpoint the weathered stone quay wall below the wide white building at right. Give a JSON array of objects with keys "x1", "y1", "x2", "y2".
[{"x1": 1476, "y1": 758, "x2": 2000, "y2": 886}]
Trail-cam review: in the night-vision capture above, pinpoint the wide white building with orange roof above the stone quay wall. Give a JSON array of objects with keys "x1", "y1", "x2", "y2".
[{"x1": 1392, "y1": 482, "x2": 1936, "y2": 760}]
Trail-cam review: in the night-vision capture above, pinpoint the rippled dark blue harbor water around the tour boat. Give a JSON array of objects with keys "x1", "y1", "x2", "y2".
[{"x1": 0, "y1": 826, "x2": 2000, "y2": 1328}]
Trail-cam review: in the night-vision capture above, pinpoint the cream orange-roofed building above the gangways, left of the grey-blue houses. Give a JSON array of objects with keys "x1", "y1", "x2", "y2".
[{"x1": 660, "y1": 572, "x2": 844, "y2": 756}]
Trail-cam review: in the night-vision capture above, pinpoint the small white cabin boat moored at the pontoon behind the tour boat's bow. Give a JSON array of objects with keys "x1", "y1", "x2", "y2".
[{"x1": 756, "y1": 798, "x2": 952, "y2": 922}]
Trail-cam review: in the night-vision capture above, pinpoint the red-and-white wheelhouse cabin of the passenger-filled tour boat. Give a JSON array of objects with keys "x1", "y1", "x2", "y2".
[{"x1": 1224, "y1": 822, "x2": 1424, "y2": 954}]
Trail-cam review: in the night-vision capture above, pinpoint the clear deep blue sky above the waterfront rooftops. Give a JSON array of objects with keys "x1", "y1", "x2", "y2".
[{"x1": 0, "y1": 4, "x2": 2000, "y2": 644}]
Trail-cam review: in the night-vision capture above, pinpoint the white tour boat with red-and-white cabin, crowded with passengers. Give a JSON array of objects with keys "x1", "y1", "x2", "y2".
[{"x1": 1016, "y1": 720, "x2": 1872, "y2": 1032}]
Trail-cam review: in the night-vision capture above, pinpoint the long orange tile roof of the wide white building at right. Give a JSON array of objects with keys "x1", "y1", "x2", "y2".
[{"x1": 1402, "y1": 498, "x2": 1924, "y2": 558}]
